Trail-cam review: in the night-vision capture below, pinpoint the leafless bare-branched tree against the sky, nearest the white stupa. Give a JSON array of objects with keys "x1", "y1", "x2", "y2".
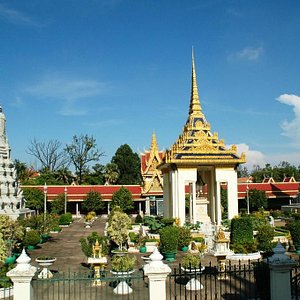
[{"x1": 26, "y1": 138, "x2": 68, "y2": 172}]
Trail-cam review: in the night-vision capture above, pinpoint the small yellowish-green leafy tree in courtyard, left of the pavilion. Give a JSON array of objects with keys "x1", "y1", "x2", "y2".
[{"x1": 107, "y1": 211, "x2": 131, "y2": 250}]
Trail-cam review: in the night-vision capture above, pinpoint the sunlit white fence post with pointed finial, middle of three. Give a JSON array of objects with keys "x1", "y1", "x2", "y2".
[{"x1": 144, "y1": 248, "x2": 171, "y2": 300}]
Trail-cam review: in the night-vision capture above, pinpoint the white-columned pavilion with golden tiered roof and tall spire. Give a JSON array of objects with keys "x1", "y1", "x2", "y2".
[{"x1": 158, "y1": 54, "x2": 246, "y2": 224}]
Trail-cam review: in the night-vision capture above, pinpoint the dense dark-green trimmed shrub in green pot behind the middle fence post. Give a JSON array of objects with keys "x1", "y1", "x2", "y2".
[{"x1": 159, "y1": 226, "x2": 179, "y2": 261}]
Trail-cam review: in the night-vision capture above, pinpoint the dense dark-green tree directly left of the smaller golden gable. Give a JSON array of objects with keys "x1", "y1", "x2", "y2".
[{"x1": 111, "y1": 144, "x2": 142, "y2": 185}]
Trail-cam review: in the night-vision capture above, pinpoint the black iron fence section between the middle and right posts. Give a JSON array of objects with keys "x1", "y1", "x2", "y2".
[{"x1": 167, "y1": 261, "x2": 270, "y2": 300}]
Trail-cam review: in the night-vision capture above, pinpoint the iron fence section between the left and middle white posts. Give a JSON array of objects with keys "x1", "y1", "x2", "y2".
[{"x1": 32, "y1": 270, "x2": 149, "y2": 300}]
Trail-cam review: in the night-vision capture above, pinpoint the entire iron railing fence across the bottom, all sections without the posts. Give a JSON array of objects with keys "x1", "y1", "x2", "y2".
[{"x1": 0, "y1": 260, "x2": 300, "y2": 300}]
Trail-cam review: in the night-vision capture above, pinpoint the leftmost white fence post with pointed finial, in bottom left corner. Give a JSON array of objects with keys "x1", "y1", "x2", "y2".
[{"x1": 6, "y1": 249, "x2": 37, "y2": 300}]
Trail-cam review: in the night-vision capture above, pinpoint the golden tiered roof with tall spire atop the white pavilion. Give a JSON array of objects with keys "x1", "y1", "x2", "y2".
[{"x1": 162, "y1": 52, "x2": 246, "y2": 165}]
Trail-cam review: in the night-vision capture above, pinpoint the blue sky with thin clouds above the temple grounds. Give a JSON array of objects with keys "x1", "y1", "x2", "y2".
[{"x1": 0, "y1": 0, "x2": 300, "y2": 168}]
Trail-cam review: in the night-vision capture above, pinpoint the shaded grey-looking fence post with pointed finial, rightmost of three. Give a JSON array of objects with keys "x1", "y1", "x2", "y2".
[{"x1": 269, "y1": 242, "x2": 296, "y2": 300}]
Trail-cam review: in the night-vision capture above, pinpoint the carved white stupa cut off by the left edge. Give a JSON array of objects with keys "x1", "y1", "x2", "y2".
[{"x1": 0, "y1": 106, "x2": 34, "y2": 220}]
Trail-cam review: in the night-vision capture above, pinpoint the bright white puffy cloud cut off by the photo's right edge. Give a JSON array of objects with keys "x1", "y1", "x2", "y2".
[{"x1": 277, "y1": 94, "x2": 300, "y2": 148}]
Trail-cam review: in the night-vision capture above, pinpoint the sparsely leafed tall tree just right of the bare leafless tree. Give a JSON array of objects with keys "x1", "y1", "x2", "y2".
[{"x1": 65, "y1": 134, "x2": 104, "y2": 184}]
